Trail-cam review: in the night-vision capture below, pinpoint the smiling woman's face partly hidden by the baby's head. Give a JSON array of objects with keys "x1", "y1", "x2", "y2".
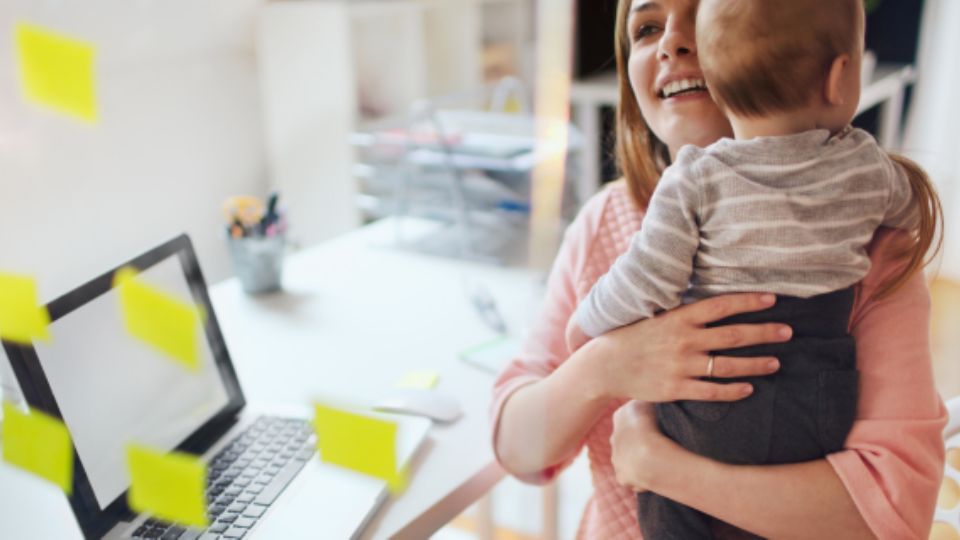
[{"x1": 627, "y1": 0, "x2": 733, "y2": 156}]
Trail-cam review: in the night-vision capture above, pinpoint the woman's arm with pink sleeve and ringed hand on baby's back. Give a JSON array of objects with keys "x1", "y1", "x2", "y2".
[{"x1": 492, "y1": 191, "x2": 789, "y2": 482}]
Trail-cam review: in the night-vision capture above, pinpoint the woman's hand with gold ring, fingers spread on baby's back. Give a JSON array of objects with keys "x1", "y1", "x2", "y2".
[{"x1": 585, "y1": 293, "x2": 792, "y2": 403}]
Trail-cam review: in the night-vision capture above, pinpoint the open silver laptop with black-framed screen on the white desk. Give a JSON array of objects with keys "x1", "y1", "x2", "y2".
[{"x1": 3, "y1": 235, "x2": 430, "y2": 540}]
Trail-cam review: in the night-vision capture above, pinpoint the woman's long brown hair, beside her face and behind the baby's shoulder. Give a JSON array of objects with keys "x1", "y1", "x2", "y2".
[{"x1": 614, "y1": 0, "x2": 943, "y2": 300}]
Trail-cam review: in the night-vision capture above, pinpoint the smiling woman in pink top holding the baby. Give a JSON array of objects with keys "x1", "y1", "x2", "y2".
[{"x1": 494, "y1": 0, "x2": 946, "y2": 538}]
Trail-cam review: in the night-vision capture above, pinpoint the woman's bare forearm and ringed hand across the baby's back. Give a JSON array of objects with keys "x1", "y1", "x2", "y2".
[{"x1": 494, "y1": 294, "x2": 790, "y2": 476}]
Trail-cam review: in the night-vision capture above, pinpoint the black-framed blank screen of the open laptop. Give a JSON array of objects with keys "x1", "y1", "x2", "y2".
[{"x1": 3, "y1": 235, "x2": 246, "y2": 538}]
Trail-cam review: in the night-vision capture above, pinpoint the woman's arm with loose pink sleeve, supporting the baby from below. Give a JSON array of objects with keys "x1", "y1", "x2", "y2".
[{"x1": 613, "y1": 231, "x2": 946, "y2": 538}]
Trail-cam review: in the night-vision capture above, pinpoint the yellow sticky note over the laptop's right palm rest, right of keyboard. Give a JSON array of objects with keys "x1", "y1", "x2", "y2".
[{"x1": 313, "y1": 404, "x2": 406, "y2": 493}]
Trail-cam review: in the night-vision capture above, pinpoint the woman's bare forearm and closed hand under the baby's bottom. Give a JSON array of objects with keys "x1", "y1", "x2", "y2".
[{"x1": 611, "y1": 401, "x2": 873, "y2": 539}]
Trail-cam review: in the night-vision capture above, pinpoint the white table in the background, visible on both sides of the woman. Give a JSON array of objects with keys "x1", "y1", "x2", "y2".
[{"x1": 570, "y1": 64, "x2": 917, "y2": 201}]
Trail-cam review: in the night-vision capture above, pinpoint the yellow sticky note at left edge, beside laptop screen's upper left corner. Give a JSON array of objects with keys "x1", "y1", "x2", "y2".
[{"x1": 0, "y1": 273, "x2": 50, "y2": 345}]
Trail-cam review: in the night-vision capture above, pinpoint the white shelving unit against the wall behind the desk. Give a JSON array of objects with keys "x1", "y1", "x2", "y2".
[{"x1": 257, "y1": 0, "x2": 534, "y2": 244}]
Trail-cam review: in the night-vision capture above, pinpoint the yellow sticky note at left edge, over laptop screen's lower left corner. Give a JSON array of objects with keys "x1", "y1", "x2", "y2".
[{"x1": 3, "y1": 401, "x2": 73, "y2": 495}]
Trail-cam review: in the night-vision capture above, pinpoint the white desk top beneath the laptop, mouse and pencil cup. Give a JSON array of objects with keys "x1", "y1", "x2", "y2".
[{"x1": 0, "y1": 219, "x2": 543, "y2": 539}]
